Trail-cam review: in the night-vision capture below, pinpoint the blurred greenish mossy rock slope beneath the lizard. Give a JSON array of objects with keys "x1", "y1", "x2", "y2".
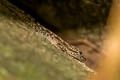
[{"x1": 0, "y1": 0, "x2": 91, "y2": 80}]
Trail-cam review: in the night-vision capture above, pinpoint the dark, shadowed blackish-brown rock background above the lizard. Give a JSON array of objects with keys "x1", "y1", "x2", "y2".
[{"x1": 9, "y1": 0, "x2": 112, "y2": 30}]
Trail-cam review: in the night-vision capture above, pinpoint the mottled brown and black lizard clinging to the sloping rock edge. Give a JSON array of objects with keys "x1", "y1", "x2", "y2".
[{"x1": 30, "y1": 22, "x2": 86, "y2": 62}]
